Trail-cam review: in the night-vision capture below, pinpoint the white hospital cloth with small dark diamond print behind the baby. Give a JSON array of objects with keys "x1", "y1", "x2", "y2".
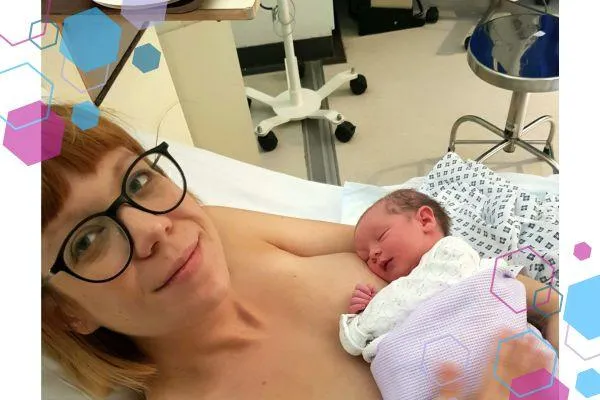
[{"x1": 418, "y1": 153, "x2": 559, "y2": 287}]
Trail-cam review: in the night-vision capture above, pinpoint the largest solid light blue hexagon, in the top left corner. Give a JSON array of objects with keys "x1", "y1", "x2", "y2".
[{"x1": 60, "y1": 7, "x2": 121, "y2": 72}]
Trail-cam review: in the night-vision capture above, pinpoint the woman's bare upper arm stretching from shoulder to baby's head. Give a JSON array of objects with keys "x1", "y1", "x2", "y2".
[{"x1": 207, "y1": 207, "x2": 354, "y2": 257}]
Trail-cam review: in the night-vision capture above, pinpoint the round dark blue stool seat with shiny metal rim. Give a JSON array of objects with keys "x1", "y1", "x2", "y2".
[{"x1": 467, "y1": 14, "x2": 559, "y2": 93}]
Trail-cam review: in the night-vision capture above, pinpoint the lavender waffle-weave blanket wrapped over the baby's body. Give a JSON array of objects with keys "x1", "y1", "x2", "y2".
[{"x1": 371, "y1": 269, "x2": 553, "y2": 400}]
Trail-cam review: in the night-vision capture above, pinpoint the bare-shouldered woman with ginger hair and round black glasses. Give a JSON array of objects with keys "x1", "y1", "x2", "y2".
[{"x1": 42, "y1": 106, "x2": 552, "y2": 400}]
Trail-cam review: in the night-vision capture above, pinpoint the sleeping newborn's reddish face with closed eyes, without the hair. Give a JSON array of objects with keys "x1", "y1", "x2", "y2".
[{"x1": 354, "y1": 202, "x2": 442, "y2": 282}]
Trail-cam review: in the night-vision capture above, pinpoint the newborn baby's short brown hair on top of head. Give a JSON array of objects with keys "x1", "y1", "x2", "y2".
[{"x1": 359, "y1": 189, "x2": 451, "y2": 236}]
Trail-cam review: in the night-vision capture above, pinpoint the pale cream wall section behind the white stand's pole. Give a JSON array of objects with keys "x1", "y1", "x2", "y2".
[{"x1": 231, "y1": 0, "x2": 334, "y2": 48}]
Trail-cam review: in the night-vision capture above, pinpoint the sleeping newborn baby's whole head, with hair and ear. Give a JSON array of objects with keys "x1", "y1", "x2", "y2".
[{"x1": 354, "y1": 189, "x2": 450, "y2": 282}]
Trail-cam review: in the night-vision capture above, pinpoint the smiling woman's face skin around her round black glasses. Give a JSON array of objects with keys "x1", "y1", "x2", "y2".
[{"x1": 42, "y1": 148, "x2": 229, "y2": 337}]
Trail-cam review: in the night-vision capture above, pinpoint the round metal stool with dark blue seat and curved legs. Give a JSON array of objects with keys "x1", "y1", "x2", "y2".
[{"x1": 448, "y1": 14, "x2": 559, "y2": 173}]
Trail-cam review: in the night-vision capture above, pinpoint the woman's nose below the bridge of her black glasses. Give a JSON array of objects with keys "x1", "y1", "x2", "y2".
[{"x1": 119, "y1": 207, "x2": 173, "y2": 258}]
